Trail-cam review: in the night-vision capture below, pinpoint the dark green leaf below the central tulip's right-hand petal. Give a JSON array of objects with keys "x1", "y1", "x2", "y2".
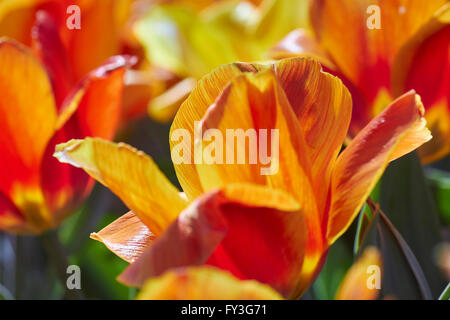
[{"x1": 380, "y1": 153, "x2": 445, "y2": 298}]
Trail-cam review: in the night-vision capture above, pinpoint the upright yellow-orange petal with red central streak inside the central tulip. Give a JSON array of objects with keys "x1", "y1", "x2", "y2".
[{"x1": 195, "y1": 68, "x2": 324, "y2": 282}]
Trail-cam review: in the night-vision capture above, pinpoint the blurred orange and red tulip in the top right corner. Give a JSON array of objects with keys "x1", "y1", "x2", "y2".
[{"x1": 272, "y1": 0, "x2": 450, "y2": 162}]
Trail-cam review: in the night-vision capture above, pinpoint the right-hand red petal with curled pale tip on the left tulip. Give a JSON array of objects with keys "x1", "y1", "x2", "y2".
[{"x1": 41, "y1": 56, "x2": 134, "y2": 221}]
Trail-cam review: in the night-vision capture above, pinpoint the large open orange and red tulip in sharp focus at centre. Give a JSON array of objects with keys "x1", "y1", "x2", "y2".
[{"x1": 56, "y1": 59, "x2": 431, "y2": 297}]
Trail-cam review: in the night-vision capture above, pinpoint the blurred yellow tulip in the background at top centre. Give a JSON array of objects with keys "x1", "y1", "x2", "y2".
[{"x1": 133, "y1": 0, "x2": 308, "y2": 122}]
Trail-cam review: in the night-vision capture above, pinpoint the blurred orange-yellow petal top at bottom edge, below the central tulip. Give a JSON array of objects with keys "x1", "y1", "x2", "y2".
[{"x1": 137, "y1": 267, "x2": 282, "y2": 300}]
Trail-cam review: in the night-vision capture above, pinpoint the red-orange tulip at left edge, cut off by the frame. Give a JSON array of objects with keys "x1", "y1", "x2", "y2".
[{"x1": 0, "y1": 33, "x2": 130, "y2": 234}]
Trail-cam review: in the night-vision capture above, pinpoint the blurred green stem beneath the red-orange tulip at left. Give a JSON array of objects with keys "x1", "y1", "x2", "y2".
[{"x1": 41, "y1": 230, "x2": 83, "y2": 300}]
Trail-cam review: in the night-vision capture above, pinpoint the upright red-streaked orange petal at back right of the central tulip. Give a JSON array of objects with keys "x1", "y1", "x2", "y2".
[{"x1": 275, "y1": 58, "x2": 352, "y2": 212}]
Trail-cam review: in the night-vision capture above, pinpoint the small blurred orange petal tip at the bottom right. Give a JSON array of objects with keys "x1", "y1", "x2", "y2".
[{"x1": 335, "y1": 247, "x2": 382, "y2": 300}]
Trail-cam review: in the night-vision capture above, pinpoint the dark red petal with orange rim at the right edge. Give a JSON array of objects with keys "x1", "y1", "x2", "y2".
[{"x1": 392, "y1": 4, "x2": 450, "y2": 163}]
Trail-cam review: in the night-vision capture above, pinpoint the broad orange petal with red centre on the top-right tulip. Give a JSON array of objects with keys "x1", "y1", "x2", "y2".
[{"x1": 311, "y1": 0, "x2": 447, "y2": 102}]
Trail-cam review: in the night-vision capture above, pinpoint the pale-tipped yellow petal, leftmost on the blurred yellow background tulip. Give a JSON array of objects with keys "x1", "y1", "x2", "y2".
[{"x1": 134, "y1": 5, "x2": 244, "y2": 79}]
